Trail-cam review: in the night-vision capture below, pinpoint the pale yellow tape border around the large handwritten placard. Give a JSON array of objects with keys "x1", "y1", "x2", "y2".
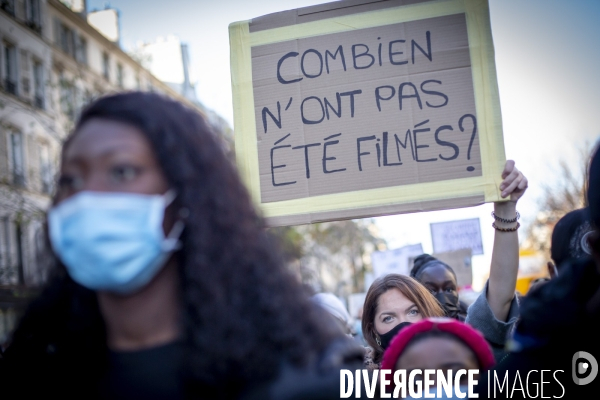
[{"x1": 229, "y1": 0, "x2": 505, "y2": 222}]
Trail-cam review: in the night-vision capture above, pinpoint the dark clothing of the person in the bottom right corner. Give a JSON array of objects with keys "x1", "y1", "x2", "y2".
[{"x1": 479, "y1": 260, "x2": 600, "y2": 399}]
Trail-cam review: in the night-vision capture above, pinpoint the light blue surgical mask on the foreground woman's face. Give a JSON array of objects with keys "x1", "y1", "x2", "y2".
[{"x1": 48, "y1": 191, "x2": 184, "y2": 294}]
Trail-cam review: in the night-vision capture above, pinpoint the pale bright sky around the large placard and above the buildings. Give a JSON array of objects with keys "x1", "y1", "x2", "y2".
[{"x1": 88, "y1": 0, "x2": 600, "y2": 288}]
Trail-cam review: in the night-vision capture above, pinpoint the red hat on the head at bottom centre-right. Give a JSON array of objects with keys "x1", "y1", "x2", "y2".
[{"x1": 381, "y1": 318, "x2": 496, "y2": 371}]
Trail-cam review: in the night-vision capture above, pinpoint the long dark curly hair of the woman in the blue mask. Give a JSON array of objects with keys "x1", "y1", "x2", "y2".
[{"x1": 7, "y1": 92, "x2": 341, "y2": 398}]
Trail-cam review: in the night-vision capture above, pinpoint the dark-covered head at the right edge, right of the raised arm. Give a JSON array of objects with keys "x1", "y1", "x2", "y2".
[{"x1": 550, "y1": 207, "x2": 592, "y2": 271}]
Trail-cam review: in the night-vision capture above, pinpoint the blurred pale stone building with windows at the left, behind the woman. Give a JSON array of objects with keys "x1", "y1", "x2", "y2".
[{"x1": 0, "y1": 0, "x2": 231, "y2": 345}]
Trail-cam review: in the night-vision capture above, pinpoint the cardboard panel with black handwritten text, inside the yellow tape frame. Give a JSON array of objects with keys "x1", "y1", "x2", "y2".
[{"x1": 252, "y1": 14, "x2": 481, "y2": 203}]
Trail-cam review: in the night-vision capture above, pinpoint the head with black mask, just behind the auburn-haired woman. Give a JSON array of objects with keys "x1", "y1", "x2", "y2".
[{"x1": 410, "y1": 254, "x2": 466, "y2": 321}]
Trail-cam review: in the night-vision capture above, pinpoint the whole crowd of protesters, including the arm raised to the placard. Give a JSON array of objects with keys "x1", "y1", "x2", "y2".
[{"x1": 0, "y1": 92, "x2": 600, "y2": 399}]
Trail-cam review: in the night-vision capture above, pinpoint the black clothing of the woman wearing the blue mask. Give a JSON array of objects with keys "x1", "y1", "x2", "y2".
[{"x1": 0, "y1": 328, "x2": 365, "y2": 400}]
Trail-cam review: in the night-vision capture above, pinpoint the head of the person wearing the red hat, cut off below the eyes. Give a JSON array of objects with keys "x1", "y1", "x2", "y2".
[{"x1": 381, "y1": 318, "x2": 495, "y2": 394}]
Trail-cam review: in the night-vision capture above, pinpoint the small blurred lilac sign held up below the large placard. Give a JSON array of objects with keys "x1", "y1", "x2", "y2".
[{"x1": 430, "y1": 218, "x2": 483, "y2": 255}]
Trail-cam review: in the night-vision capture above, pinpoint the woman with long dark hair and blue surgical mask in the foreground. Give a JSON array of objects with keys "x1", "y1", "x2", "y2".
[{"x1": 0, "y1": 92, "x2": 362, "y2": 399}]
